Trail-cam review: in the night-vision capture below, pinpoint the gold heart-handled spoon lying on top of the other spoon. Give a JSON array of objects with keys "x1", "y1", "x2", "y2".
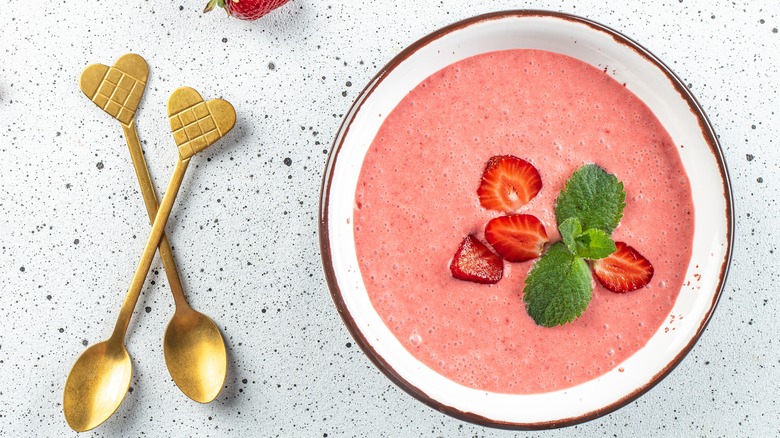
[{"x1": 63, "y1": 87, "x2": 236, "y2": 432}]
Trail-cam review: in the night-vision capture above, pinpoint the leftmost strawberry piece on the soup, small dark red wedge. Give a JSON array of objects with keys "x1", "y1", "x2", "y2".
[{"x1": 450, "y1": 234, "x2": 504, "y2": 284}]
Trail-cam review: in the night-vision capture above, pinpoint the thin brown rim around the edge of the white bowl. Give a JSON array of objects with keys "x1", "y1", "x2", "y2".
[{"x1": 319, "y1": 10, "x2": 734, "y2": 430}]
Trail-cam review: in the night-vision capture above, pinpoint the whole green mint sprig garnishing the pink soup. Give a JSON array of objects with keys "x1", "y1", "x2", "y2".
[{"x1": 523, "y1": 164, "x2": 626, "y2": 327}]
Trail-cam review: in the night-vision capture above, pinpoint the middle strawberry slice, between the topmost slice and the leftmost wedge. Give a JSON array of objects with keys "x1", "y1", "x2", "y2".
[{"x1": 485, "y1": 214, "x2": 550, "y2": 262}]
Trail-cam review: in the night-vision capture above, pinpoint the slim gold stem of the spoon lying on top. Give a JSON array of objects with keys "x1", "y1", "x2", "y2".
[{"x1": 111, "y1": 158, "x2": 190, "y2": 342}]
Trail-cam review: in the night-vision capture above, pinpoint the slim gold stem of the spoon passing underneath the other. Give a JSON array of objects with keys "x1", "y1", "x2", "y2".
[{"x1": 122, "y1": 120, "x2": 188, "y2": 309}]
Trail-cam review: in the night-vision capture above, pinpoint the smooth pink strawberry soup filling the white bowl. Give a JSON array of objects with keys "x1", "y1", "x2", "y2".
[{"x1": 354, "y1": 50, "x2": 694, "y2": 394}]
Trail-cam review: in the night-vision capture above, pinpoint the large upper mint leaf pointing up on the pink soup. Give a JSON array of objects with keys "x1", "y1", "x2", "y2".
[{"x1": 555, "y1": 164, "x2": 626, "y2": 234}]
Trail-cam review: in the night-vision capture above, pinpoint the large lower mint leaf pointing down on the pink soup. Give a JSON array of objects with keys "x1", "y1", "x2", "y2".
[{"x1": 523, "y1": 242, "x2": 593, "y2": 327}]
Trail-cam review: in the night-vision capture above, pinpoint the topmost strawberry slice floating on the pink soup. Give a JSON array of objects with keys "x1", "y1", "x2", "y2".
[{"x1": 477, "y1": 155, "x2": 542, "y2": 213}]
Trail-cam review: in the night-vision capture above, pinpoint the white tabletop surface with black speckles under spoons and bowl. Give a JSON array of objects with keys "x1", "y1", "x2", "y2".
[{"x1": 0, "y1": 0, "x2": 780, "y2": 437}]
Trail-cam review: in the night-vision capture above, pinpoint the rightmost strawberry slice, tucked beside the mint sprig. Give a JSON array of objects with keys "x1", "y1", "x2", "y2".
[{"x1": 593, "y1": 242, "x2": 654, "y2": 293}]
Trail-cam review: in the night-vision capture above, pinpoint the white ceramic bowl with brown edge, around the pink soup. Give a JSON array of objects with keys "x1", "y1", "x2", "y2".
[{"x1": 320, "y1": 11, "x2": 733, "y2": 429}]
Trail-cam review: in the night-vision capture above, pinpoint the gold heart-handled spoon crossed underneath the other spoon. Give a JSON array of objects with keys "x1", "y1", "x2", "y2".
[{"x1": 80, "y1": 53, "x2": 227, "y2": 403}]
